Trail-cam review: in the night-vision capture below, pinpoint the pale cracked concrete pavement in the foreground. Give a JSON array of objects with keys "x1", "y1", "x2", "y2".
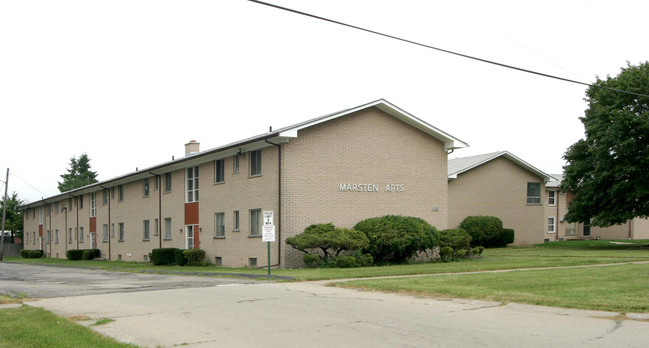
[{"x1": 8, "y1": 264, "x2": 649, "y2": 348}]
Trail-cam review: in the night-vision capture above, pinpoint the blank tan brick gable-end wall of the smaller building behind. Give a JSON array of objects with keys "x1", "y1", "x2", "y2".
[{"x1": 448, "y1": 157, "x2": 547, "y2": 245}]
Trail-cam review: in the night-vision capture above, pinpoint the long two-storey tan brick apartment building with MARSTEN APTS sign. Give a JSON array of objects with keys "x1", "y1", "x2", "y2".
[{"x1": 24, "y1": 99, "x2": 468, "y2": 267}]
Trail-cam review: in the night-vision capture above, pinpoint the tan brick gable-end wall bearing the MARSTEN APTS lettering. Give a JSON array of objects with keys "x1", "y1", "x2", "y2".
[{"x1": 282, "y1": 108, "x2": 448, "y2": 266}]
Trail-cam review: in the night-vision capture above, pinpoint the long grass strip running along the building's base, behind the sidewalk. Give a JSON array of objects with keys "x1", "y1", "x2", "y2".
[{"x1": 6, "y1": 240, "x2": 649, "y2": 280}]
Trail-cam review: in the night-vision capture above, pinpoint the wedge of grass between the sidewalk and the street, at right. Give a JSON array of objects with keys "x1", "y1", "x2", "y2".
[{"x1": 337, "y1": 264, "x2": 649, "y2": 313}]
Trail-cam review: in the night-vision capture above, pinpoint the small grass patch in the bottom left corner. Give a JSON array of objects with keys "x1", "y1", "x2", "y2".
[{"x1": 0, "y1": 304, "x2": 136, "y2": 348}]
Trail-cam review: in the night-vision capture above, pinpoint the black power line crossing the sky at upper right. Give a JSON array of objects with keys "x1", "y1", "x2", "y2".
[{"x1": 248, "y1": 0, "x2": 649, "y2": 98}]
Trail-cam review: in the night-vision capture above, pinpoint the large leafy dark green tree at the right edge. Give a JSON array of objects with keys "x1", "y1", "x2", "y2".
[{"x1": 562, "y1": 62, "x2": 649, "y2": 226}]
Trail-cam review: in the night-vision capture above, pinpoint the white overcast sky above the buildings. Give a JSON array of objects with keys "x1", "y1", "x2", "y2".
[{"x1": 0, "y1": 0, "x2": 649, "y2": 202}]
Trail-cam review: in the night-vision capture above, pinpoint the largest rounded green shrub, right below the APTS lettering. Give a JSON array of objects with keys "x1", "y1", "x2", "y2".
[{"x1": 354, "y1": 215, "x2": 439, "y2": 263}]
